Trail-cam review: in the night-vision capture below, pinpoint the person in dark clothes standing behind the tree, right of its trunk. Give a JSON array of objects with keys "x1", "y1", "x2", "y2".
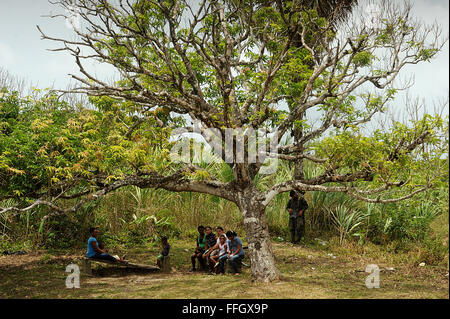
[{"x1": 286, "y1": 191, "x2": 308, "y2": 244}]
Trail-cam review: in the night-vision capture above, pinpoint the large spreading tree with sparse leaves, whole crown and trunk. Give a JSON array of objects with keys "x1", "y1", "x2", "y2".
[{"x1": 2, "y1": 0, "x2": 445, "y2": 281}]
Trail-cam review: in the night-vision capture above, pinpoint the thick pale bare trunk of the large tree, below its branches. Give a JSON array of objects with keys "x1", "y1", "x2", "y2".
[{"x1": 238, "y1": 192, "x2": 280, "y2": 282}]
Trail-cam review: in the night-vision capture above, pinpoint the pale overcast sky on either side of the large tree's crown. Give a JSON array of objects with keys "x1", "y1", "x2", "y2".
[{"x1": 0, "y1": 0, "x2": 449, "y2": 117}]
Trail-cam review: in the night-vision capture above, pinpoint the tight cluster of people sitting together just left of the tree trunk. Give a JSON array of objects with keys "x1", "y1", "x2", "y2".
[{"x1": 191, "y1": 226, "x2": 245, "y2": 275}]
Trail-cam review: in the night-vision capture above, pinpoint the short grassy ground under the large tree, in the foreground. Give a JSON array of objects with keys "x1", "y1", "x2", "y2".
[{"x1": 0, "y1": 240, "x2": 449, "y2": 299}]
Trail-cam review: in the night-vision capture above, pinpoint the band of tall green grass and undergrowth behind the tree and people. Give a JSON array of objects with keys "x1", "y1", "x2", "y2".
[{"x1": 0, "y1": 161, "x2": 448, "y2": 255}]
